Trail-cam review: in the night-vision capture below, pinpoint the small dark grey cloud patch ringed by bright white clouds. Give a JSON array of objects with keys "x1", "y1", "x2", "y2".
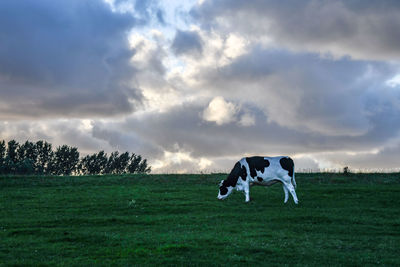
[{"x1": 172, "y1": 30, "x2": 203, "y2": 55}]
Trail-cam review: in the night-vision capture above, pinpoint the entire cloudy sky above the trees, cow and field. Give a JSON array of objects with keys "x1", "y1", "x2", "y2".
[{"x1": 0, "y1": 0, "x2": 400, "y2": 173}]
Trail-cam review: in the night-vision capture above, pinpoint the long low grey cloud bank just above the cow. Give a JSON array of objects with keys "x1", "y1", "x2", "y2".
[{"x1": 121, "y1": 103, "x2": 328, "y2": 159}]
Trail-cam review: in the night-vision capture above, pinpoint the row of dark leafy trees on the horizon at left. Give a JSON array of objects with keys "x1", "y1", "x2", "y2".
[{"x1": 0, "y1": 140, "x2": 151, "y2": 175}]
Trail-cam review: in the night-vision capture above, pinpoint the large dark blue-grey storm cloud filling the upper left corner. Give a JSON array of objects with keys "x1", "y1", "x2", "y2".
[{"x1": 0, "y1": 0, "x2": 141, "y2": 118}]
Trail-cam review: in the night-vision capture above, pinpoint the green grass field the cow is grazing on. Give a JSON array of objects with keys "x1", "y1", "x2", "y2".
[{"x1": 0, "y1": 174, "x2": 400, "y2": 266}]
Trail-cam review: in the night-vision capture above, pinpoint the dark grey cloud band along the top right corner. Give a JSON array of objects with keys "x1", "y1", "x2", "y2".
[{"x1": 191, "y1": 0, "x2": 400, "y2": 60}]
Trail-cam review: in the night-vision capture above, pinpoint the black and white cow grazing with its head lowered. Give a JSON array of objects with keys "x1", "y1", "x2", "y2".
[{"x1": 218, "y1": 156, "x2": 298, "y2": 204}]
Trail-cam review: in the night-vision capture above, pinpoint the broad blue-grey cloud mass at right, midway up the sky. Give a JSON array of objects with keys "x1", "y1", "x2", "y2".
[{"x1": 197, "y1": 47, "x2": 398, "y2": 136}]
